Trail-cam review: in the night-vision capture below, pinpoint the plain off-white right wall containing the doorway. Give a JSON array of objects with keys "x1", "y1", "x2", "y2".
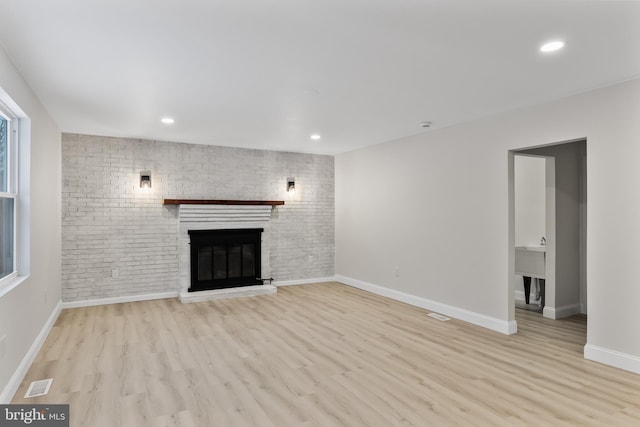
[{"x1": 336, "y1": 79, "x2": 640, "y2": 372}]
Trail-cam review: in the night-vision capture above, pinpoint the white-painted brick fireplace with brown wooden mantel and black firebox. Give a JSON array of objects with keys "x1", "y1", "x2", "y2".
[{"x1": 169, "y1": 199, "x2": 284, "y2": 303}]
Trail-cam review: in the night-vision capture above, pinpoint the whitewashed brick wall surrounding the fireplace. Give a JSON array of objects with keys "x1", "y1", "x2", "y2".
[{"x1": 62, "y1": 134, "x2": 334, "y2": 301}]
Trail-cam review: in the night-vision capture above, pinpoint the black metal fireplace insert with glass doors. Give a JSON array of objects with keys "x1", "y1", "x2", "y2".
[{"x1": 188, "y1": 228, "x2": 264, "y2": 292}]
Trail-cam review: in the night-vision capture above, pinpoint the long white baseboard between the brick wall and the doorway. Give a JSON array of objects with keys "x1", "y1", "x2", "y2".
[{"x1": 335, "y1": 275, "x2": 518, "y2": 335}]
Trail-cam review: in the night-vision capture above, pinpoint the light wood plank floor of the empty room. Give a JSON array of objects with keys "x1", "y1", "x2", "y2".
[{"x1": 13, "y1": 283, "x2": 640, "y2": 427}]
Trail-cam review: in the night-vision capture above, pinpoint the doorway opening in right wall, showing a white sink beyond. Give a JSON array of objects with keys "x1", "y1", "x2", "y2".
[{"x1": 508, "y1": 139, "x2": 587, "y2": 332}]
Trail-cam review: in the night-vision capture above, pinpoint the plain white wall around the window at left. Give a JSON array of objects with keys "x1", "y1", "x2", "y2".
[{"x1": 0, "y1": 44, "x2": 61, "y2": 403}]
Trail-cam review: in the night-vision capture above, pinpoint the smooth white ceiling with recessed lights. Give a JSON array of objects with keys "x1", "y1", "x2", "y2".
[{"x1": 0, "y1": 0, "x2": 640, "y2": 154}]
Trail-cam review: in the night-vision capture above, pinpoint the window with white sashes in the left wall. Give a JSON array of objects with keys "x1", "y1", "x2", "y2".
[{"x1": 0, "y1": 105, "x2": 18, "y2": 284}]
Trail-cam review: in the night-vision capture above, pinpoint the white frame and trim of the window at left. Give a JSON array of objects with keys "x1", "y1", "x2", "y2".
[{"x1": 0, "y1": 102, "x2": 19, "y2": 295}]
